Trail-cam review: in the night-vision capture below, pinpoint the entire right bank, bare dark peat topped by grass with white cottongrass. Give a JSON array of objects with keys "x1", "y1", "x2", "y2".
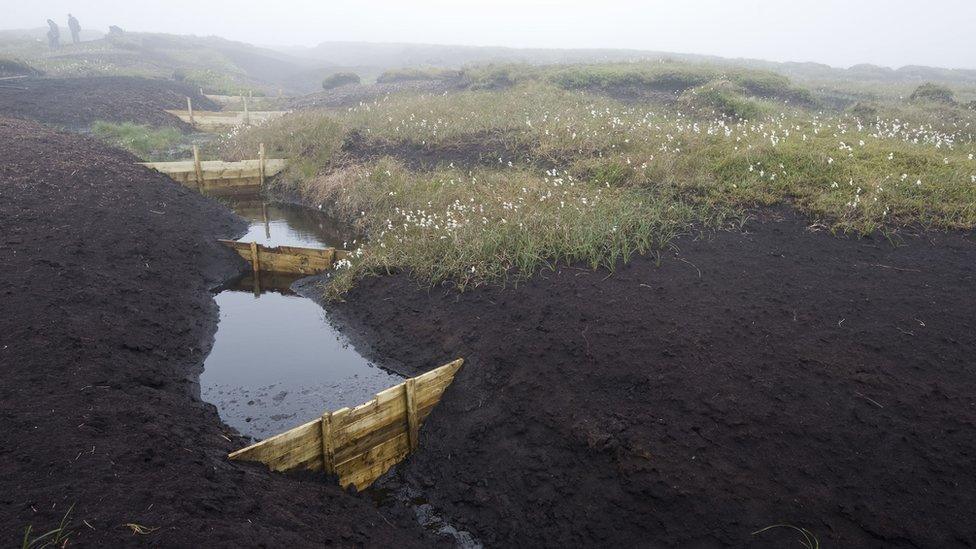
[{"x1": 224, "y1": 60, "x2": 976, "y2": 547}]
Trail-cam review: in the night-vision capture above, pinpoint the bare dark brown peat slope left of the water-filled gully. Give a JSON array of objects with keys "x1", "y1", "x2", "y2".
[{"x1": 0, "y1": 119, "x2": 433, "y2": 547}]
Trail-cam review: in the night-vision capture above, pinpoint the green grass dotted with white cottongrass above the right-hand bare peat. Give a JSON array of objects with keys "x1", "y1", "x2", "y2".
[{"x1": 225, "y1": 67, "x2": 976, "y2": 296}]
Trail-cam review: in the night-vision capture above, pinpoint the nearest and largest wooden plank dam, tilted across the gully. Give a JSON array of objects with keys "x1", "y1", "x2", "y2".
[{"x1": 229, "y1": 359, "x2": 463, "y2": 490}]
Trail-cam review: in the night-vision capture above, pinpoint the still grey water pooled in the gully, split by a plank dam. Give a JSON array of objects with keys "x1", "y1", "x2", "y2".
[{"x1": 200, "y1": 200, "x2": 403, "y2": 439}]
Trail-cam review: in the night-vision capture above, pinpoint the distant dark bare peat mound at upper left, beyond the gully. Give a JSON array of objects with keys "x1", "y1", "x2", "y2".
[{"x1": 0, "y1": 76, "x2": 219, "y2": 131}]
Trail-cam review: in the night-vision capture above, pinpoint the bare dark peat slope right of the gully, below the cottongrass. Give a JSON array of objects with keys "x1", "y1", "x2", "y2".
[{"x1": 332, "y1": 212, "x2": 976, "y2": 547}]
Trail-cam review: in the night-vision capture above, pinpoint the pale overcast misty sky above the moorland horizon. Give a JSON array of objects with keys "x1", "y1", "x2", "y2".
[{"x1": 7, "y1": 0, "x2": 976, "y2": 68}]
